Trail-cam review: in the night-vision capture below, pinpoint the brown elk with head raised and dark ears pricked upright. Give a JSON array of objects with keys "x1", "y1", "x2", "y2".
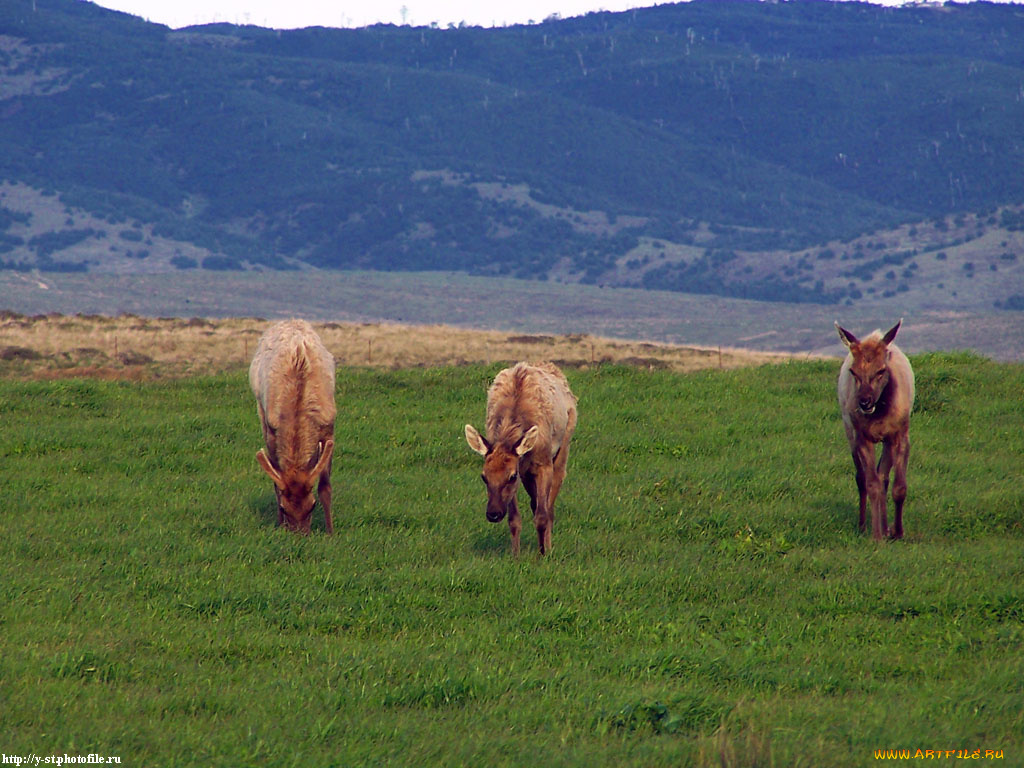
[{"x1": 836, "y1": 319, "x2": 913, "y2": 540}]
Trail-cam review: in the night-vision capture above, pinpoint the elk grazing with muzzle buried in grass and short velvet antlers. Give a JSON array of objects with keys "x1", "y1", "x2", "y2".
[{"x1": 249, "y1": 319, "x2": 336, "y2": 534}]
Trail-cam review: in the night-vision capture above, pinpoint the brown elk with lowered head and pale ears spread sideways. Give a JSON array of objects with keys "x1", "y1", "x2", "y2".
[{"x1": 466, "y1": 362, "x2": 577, "y2": 555}]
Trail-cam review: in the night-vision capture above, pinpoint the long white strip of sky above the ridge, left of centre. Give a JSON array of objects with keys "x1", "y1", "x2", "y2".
[{"x1": 96, "y1": 0, "x2": 656, "y2": 29}]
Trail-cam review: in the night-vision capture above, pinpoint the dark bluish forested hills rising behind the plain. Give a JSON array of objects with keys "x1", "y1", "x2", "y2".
[{"x1": 0, "y1": 0, "x2": 1024, "y2": 301}]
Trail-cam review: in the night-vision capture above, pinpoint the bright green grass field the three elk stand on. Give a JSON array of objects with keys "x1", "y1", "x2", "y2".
[{"x1": 0, "y1": 354, "x2": 1024, "y2": 767}]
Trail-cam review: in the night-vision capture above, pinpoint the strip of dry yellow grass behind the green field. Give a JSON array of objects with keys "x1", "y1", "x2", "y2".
[{"x1": 0, "y1": 312, "x2": 792, "y2": 379}]
